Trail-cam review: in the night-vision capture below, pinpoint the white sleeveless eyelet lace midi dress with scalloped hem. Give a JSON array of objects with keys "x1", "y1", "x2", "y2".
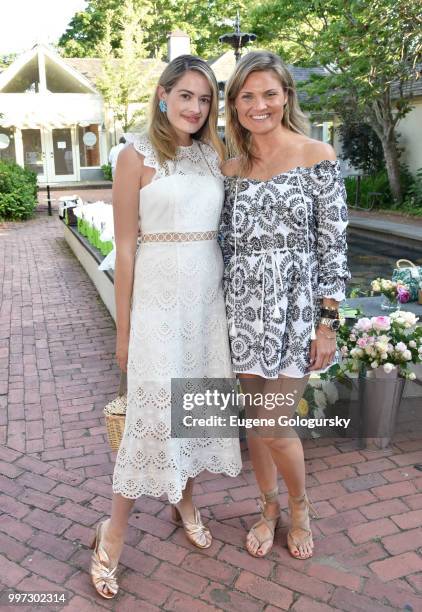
[{"x1": 113, "y1": 136, "x2": 241, "y2": 504}]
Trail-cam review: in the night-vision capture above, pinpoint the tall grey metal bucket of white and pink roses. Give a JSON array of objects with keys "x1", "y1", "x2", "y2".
[{"x1": 339, "y1": 310, "x2": 422, "y2": 448}]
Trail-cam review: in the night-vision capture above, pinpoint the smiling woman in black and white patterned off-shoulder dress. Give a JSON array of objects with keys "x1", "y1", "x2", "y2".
[{"x1": 220, "y1": 52, "x2": 349, "y2": 559}]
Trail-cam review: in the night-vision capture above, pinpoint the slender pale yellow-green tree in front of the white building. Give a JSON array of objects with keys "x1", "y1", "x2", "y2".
[{"x1": 97, "y1": 0, "x2": 162, "y2": 131}]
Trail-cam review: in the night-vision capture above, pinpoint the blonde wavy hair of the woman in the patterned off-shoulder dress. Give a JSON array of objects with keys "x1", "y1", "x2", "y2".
[{"x1": 225, "y1": 51, "x2": 309, "y2": 172}]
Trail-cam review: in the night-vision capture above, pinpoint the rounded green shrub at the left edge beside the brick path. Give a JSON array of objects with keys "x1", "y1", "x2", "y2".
[{"x1": 0, "y1": 161, "x2": 38, "y2": 220}]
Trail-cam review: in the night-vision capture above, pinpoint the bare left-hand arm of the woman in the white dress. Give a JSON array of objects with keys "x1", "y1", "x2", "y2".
[{"x1": 113, "y1": 146, "x2": 143, "y2": 371}]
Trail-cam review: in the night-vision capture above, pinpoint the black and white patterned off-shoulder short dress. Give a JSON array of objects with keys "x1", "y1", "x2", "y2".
[{"x1": 220, "y1": 160, "x2": 350, "y2": 378}]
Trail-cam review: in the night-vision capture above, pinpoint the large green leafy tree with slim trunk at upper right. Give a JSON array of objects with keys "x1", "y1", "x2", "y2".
[{"x1": 252, "y1": 0, "x2": 421, "y2": 202}]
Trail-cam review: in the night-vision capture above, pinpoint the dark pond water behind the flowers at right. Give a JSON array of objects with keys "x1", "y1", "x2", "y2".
[{"x1": 347, "y1": 230, "x2": 422, "y2": 294}]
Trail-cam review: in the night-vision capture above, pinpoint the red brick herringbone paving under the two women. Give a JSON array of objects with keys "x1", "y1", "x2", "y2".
[{"x1": 0, "y1": 208, "x2": 422, "y2": 612}]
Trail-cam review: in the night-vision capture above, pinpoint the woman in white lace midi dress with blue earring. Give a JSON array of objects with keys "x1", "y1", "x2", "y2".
[{"x1": 91, "y1": 55, "x2": 241, "y2": 598}]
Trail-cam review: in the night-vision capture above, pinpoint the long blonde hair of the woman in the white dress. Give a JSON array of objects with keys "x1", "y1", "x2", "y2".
[{"x1": 148, "y1": 55, "x2": 223, "y2": 163}]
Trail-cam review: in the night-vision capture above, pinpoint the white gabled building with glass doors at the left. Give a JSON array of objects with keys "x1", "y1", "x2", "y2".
[{"x1": 0, "y1": 45, "x2": 165, "y2": 183}]
